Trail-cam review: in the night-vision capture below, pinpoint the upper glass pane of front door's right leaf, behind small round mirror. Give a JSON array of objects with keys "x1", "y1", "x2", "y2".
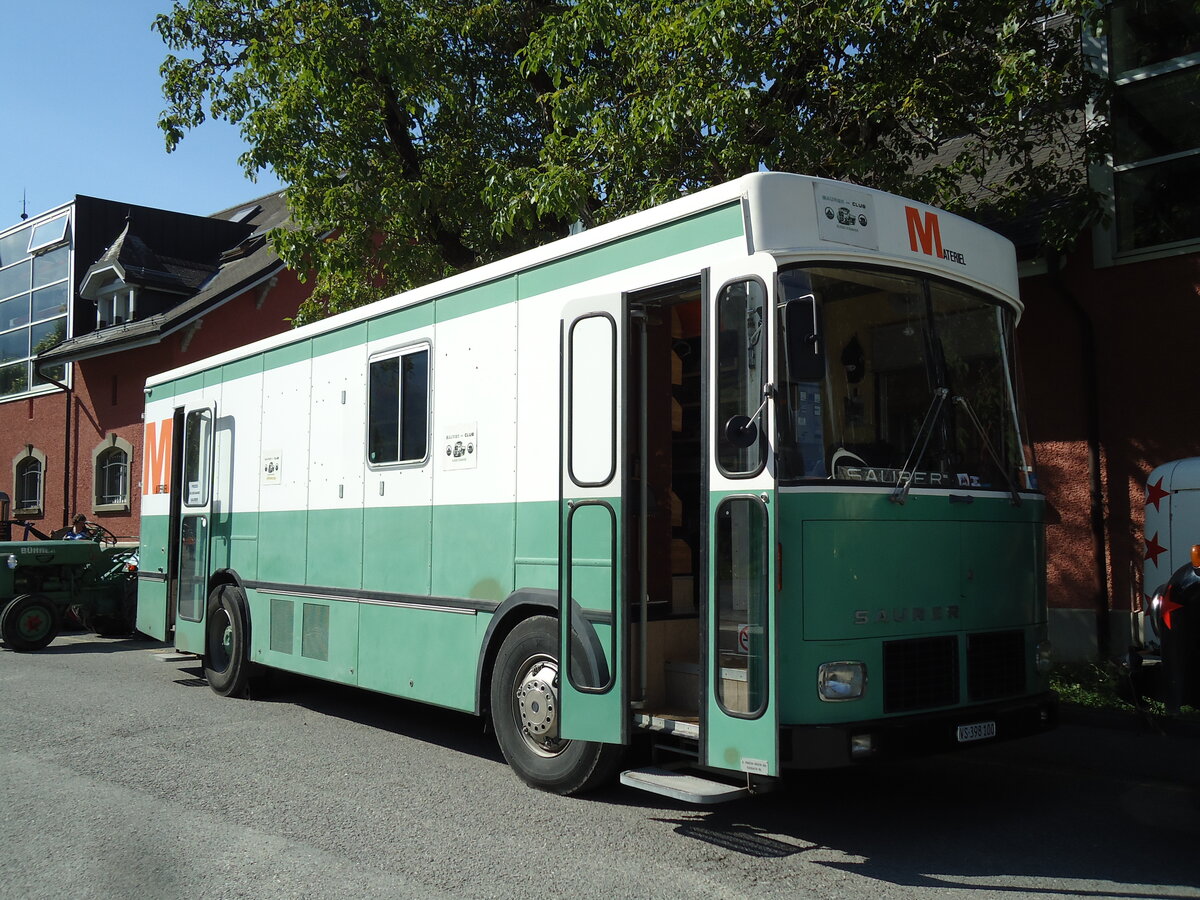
[{"x1": 715, "y1": 280, "x2": 767, "y2": 475}]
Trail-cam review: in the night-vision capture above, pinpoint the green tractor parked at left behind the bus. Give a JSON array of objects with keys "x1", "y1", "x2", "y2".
[{"x1": 0, "y1": 492, "x2": 138, "y2": 650}]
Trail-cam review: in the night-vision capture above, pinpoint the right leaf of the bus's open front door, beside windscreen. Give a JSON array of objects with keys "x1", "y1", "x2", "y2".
[{"x1": 701, "y1": 258, "x2": 779, "y2": 775}]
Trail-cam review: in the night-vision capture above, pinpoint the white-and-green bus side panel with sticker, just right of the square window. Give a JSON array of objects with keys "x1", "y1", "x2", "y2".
[{"x1": 432, "y1": 300, "x2": 520, "y2": 602}]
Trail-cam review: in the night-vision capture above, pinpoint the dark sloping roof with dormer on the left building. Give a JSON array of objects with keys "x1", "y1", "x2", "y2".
[{"x1": 37, "y1": 191, "x2": 288, "y2": 364}]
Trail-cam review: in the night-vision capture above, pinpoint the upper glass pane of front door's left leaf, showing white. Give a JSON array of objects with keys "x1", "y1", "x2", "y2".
[{"x1": 568, "y1": 316, "x2": 617, "y2": 487}]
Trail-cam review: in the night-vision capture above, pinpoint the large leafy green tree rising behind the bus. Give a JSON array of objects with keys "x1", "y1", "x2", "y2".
[{"x1": 155, "y1": 0, "x2": 1099, "y2": 318}]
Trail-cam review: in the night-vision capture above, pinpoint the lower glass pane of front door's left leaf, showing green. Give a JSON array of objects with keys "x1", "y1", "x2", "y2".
[{"x1": 566, "y1": 503, "x2": 617, "y2": 694}]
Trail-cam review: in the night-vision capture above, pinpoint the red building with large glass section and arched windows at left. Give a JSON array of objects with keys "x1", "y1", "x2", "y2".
[{"x1": 0, "y1": 193, "x2": 307, "y2": 540}]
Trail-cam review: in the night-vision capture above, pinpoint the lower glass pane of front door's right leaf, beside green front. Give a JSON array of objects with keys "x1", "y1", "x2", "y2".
[{"x1": 714, "y1": 497, "x2": 769, "y2": 718}]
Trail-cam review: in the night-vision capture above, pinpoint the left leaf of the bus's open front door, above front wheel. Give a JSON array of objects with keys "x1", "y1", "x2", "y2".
[{"x1": 559, "y1": 295, "x2": 629, "y2": 744}]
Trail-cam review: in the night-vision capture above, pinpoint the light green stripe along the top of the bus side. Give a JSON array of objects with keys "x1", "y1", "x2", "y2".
[{"x1": 140, "y1": 200, "x2": 745, "y2": 397}]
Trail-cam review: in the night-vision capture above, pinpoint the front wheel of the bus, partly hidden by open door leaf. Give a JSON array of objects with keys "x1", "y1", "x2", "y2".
[{"x1": 491, "y1": 616, "x2": 624, "y2": 794}]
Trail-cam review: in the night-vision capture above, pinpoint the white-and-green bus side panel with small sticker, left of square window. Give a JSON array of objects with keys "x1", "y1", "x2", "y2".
[{"x1": 256, "y1": 341, "x2": 311, "y2": 585}]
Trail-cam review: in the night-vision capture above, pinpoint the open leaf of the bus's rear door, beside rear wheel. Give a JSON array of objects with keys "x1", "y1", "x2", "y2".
[{"x1": 169, "y1": 403, "x2": 216, "y2": 655}]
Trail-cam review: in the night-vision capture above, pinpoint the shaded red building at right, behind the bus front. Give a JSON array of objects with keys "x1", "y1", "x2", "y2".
[{"x1": 1018, "y1": 0, "x2": 1200, "y2": 659}]
